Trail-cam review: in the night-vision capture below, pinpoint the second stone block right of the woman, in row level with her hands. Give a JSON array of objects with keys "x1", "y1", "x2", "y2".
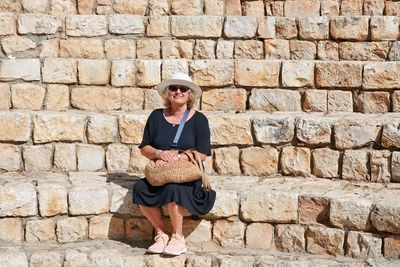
[{"x1": 240, "y1": 146, "x2": 279, "y2": 176}]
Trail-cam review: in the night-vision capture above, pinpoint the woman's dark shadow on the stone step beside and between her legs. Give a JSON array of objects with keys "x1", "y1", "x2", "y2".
[{"x1": 103, "y1": 173, "x2": 201, "y2": 248}]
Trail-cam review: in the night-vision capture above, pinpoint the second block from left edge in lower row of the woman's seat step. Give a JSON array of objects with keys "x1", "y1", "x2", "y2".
[{"x1": 25, "y1": 218, "x2": 56, "y2": 242}]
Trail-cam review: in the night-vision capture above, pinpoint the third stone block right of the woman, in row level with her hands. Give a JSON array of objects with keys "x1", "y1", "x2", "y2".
[{"x1": 281, "y1": 147, "x2": 311, "y2": 176}]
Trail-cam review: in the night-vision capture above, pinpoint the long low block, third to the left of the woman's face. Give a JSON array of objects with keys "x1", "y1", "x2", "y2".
[{"x1": 71, "y1": 86, "x2": 121, "y2": 111}]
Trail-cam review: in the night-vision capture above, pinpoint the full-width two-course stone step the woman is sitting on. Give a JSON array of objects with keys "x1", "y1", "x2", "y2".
[{"x1": 0, "y1": 172, "x2": 400, "y2": 259}]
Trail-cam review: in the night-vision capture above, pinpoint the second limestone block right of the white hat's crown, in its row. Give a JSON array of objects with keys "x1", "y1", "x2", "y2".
[{"x1": 235, "y1": 59, "x2": 280, "y2": 87}]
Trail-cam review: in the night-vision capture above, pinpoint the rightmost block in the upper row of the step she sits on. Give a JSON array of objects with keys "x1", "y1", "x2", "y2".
[{"x1": 371, "y1": 203, "x2": 400, "y2": 234}]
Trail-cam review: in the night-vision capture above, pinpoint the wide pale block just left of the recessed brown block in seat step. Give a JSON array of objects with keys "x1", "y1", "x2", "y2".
[{"x1": 240, "y1": 191, "x2": 298, "y2": 223}]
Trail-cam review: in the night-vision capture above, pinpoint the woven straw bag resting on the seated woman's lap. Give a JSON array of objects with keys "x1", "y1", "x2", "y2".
[{"x1": 144, "y1": 149, "x2": 211, "y2": 190}]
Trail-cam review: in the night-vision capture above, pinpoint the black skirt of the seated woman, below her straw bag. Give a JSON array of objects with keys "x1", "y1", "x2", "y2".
[{"x1": 133, "y1": 178, "x2": 216, "y2": 216}]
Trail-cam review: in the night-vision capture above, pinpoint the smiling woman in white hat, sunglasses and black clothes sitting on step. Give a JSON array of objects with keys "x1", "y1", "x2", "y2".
[{"x1": 133, "y1": 73, "x2": 215, "y2": 255}]
